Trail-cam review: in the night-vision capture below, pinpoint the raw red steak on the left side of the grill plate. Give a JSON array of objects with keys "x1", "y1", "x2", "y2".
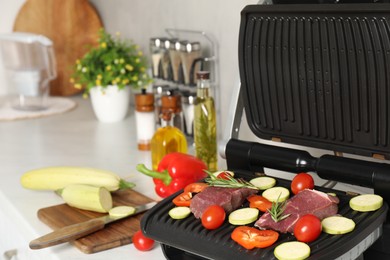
[{"x1": 190, "y1": 186, "x2": 257, "y2": 218}]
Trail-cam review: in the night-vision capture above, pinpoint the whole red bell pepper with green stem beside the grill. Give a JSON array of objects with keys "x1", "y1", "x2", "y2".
[{"x1": 137, "y1": 152, "x2": 207, "y2": 198}]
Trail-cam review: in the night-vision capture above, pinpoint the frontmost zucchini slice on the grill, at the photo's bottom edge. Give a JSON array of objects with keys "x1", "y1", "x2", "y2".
[{"x1": 274, "y1": 241, "x2": 310, "y2": 260}]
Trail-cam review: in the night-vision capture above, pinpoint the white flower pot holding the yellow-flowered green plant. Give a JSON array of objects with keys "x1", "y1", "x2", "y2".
[{"x1": 89, "y1": 85, "x2": 130, "y2": 123}]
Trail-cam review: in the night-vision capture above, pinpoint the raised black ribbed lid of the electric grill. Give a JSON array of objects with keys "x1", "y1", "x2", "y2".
[{"x1": 239, "y1": 4, "x2": 390, "y2": 159}]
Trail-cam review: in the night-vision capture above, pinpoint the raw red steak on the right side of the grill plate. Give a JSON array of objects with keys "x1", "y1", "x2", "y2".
[{"x1": 255, "y1": 189, "x2": 339, "y2": 233}]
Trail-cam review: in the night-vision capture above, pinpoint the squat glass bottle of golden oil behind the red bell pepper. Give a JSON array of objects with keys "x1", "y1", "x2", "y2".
[{"x1": 151, "y1": 110, "x2": 187, "y2": 170}]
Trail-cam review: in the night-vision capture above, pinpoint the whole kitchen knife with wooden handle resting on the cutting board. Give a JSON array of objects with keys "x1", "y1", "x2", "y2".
[{"x1": 29, "y1": 202, "x2": 157, "y2": 249}]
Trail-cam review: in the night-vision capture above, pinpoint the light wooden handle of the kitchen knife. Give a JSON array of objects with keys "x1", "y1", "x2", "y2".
[{"x1": 29, "y1": 218, "x2": 105, "y2": 249}]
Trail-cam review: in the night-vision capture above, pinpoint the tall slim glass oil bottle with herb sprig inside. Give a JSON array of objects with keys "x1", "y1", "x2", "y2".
[{"x1": 194, "y1": 71, "x2": 218, "y2": 171}]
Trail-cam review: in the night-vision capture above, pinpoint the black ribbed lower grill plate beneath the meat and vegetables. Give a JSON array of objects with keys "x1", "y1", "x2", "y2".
[{"x1": 141, "y1": 173, "x2": 388, "y2": 260}]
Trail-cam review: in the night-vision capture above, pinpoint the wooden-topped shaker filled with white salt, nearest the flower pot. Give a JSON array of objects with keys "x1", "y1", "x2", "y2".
[{"x1": 135, "y1": 89, "x2": 155, "y2": 151}]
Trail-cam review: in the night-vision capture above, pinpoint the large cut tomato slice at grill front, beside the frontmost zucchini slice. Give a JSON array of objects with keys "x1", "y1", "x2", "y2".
[{"x1": 230, "y1": 226, "x2": 279, "y2": 249}]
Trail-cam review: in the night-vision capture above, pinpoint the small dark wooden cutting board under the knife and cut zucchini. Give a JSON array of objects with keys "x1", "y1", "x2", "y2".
[{"x1": 38, "y1": 189, "x2": 153, "y2": 254}]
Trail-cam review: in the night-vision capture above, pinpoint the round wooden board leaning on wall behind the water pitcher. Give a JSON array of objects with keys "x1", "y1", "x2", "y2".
[{"x1": 13, "y1": 0, "x2": 103, "y2": 96}]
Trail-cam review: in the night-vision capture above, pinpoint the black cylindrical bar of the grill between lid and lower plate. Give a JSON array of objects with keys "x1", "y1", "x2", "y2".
[{"x1": 226, "y1": 139, "x2": 390, "y2": 202}]
